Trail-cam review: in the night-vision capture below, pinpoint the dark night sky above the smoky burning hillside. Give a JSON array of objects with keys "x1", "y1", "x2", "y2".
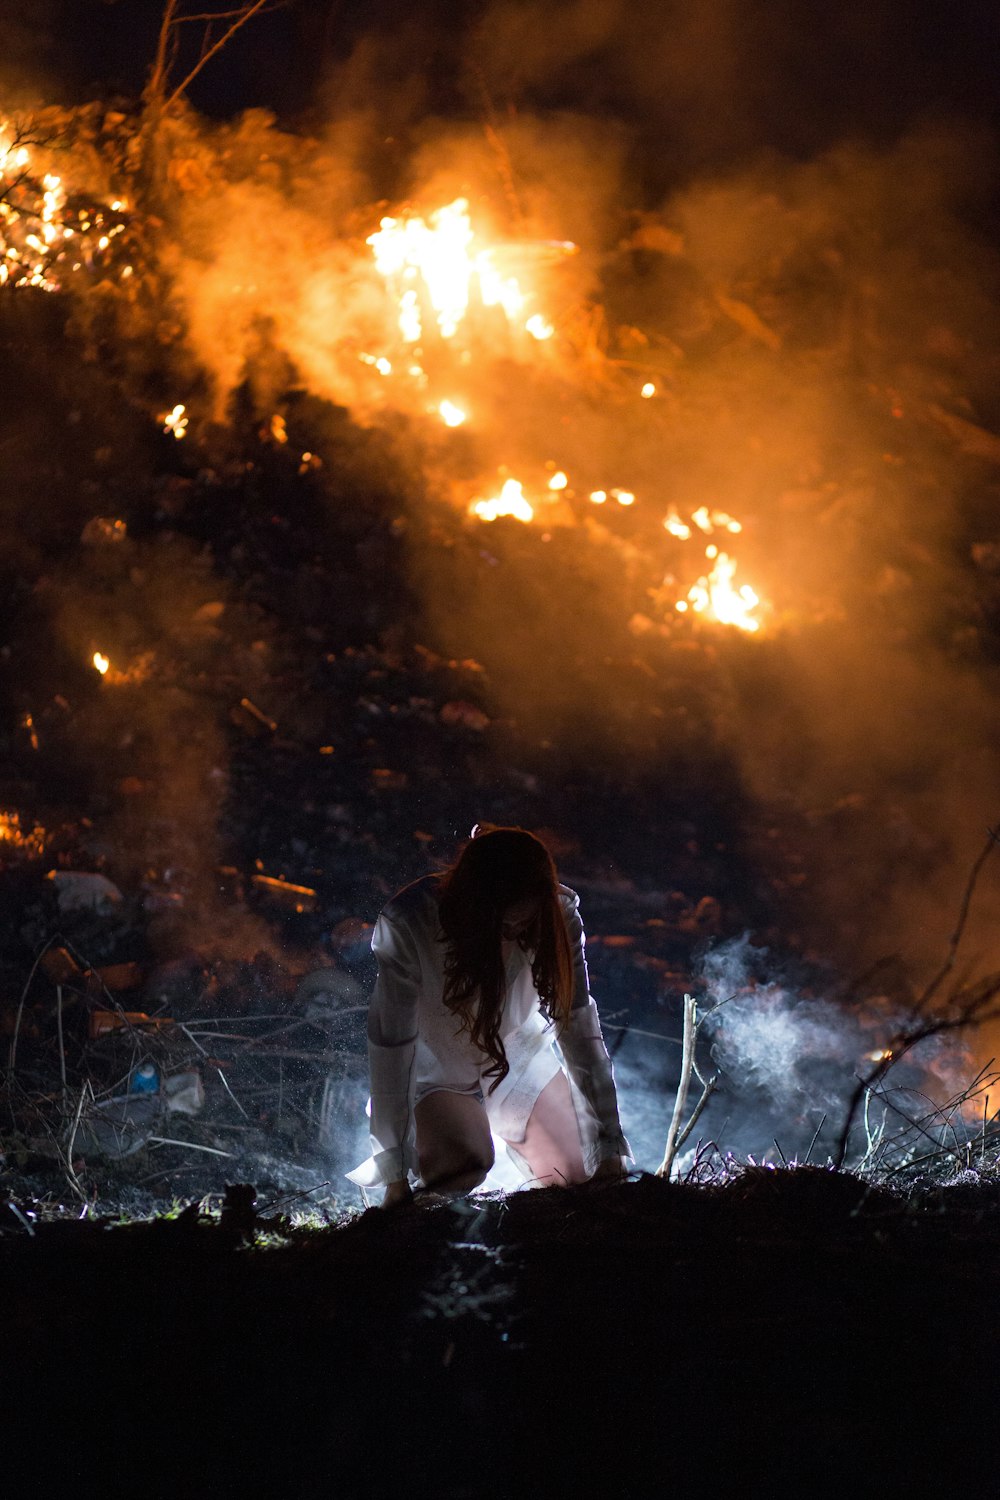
[{"x1": 7, "y1": 0, "x2": 1000, "y2": 191}]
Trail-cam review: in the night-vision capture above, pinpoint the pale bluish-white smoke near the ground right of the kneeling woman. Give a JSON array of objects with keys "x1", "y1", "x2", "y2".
[{"x1": 609, "y1": 935, "x2": 984, "y2": 1172}]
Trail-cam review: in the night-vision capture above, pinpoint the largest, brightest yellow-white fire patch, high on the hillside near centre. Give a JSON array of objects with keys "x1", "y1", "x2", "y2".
[{"x1": 366, "y1": 198, "x2": 563, "y2": 344}]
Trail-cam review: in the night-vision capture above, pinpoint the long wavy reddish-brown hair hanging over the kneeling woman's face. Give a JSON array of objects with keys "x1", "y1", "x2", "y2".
[{"x1": 439, "y1": 824, "x2": 573, "y2": 1094}]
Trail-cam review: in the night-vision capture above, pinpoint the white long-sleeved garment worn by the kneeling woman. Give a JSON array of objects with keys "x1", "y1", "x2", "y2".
[{"x1": 348, "y1": 876, "x2": 631, "y2": 1188}]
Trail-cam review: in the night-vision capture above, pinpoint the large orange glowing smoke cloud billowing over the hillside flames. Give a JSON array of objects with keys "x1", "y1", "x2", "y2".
[{"x1": 7, "y1": 0, "x2": 1000, "y2": 990}]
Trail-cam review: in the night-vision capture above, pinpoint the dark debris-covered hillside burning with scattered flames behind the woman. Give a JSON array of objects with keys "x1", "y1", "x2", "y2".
[{"x1": 0, "y1": 55, "x2": 997, "y2": 1206}]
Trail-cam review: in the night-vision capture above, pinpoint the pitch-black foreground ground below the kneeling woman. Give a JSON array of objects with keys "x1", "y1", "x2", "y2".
[{"x1": 0, "y1": 1169, "x2": 1000, "y2": 1500}]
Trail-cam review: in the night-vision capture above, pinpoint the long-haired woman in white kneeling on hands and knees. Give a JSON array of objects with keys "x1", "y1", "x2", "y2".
[{"x1": 348, "y1": 825, "x2": 631, "y2": 1208}]
